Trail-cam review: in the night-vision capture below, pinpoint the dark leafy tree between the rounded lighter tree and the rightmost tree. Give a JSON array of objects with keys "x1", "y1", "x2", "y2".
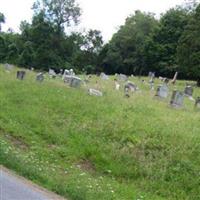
[{"x1": 147, "y1": 7, "x2": 189, "y2": 76}]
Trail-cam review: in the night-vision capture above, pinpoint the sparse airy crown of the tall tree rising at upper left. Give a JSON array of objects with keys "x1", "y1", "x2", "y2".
[{"x1": 33, "y1": 0, "x2": 81, "y2": 33}]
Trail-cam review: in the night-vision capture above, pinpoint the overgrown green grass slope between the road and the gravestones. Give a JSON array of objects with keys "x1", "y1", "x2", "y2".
[{"x1": 0, "y1": 66, "x2": 200, "y2": 200}]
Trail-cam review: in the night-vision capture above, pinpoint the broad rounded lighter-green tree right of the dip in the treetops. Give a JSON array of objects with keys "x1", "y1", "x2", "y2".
[{"x1": 101, "y1": 11, "x2": 158, "y2": 74}]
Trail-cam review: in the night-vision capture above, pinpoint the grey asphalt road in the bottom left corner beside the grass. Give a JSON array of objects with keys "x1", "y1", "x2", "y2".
[{"x1": 0, "y1": 166, "x2": 64, "y2": 200}]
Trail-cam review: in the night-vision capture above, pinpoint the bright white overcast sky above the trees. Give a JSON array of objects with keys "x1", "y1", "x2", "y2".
[{"x1": 0, "y1": 0, "x2": 184, "y2": 41}]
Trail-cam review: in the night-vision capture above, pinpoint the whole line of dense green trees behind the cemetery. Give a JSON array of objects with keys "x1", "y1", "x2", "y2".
[{"x1": 0, "y1": 0, "x2": 200, "y2": 83}]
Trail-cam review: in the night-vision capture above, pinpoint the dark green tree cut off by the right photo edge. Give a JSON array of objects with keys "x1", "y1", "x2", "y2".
[{"x1": 178, "y1": 5, "x2": 200, "y2": 86}]
